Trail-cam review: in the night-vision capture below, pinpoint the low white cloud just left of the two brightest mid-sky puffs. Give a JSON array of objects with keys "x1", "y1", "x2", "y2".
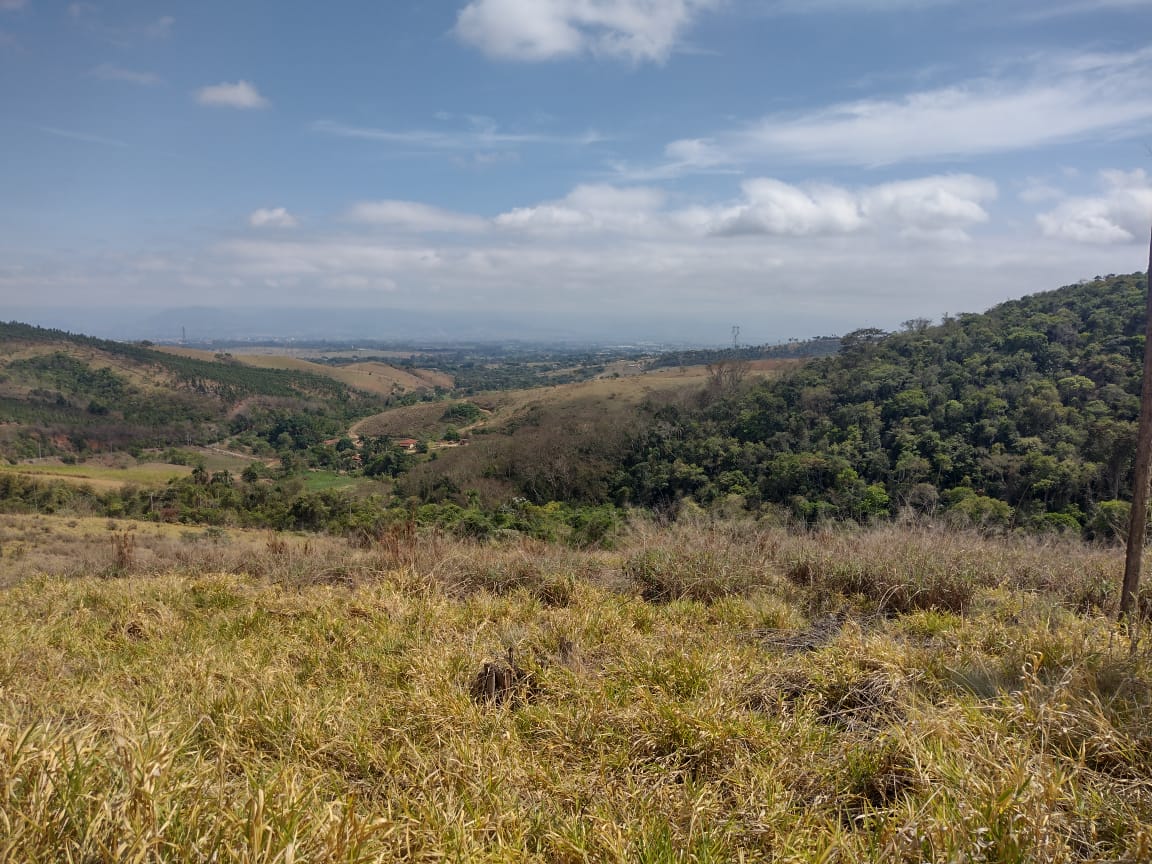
[{"x1": 495, "y1": 184, "x2": 665, "y2": 233}]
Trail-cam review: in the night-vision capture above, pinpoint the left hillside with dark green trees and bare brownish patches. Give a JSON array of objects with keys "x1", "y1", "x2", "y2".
[{"x1": 0, "y1": 323, "x2": 381, "y2": 457}]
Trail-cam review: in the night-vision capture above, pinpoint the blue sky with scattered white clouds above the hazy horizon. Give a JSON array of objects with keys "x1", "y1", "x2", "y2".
[{"x1": 0, "y1": 0, "x2": 1152, "y2": 342}]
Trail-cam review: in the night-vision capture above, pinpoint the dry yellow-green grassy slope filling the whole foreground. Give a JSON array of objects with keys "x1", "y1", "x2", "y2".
[{"x1": 0, "y1": 517, "x2": 1152, "y2": 862}]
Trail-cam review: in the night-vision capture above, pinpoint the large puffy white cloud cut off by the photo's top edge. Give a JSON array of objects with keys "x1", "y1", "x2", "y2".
[{"x1": 455, "y1": 0, "x2": 720, "y2": 62}]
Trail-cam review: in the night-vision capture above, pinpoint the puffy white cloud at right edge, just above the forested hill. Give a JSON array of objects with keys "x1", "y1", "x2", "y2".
[{"x1": 1037, "y1": 170, "x2": 1152, "y2": 244}]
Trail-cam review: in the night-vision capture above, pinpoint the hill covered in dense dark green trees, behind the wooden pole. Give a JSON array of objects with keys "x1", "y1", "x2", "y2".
[{"x1": 616, "y1": 274, "x2": 1145, "y2": 536}]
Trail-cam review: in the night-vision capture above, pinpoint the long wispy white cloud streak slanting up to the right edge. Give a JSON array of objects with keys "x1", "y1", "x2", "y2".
[{"x1": 664, "y1": 50, "x2": 1152, "y2": 173}]
